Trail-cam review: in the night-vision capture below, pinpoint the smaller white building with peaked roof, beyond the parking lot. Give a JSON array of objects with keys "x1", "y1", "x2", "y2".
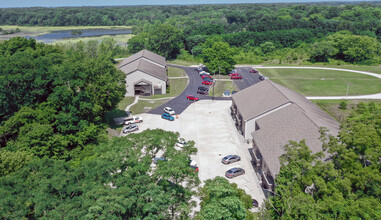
[{"x1": 119, "y1": 50, "x2": 168, "y2": 96}]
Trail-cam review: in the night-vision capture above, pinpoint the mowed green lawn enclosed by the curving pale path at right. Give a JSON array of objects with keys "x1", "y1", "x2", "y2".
[{"x1": 258, "y1": 68, "x2": 381, "y2": 96}]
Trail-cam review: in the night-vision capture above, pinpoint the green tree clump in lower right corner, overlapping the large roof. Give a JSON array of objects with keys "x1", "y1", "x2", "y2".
[{"x1": 266, "y1": 103, "x2": 381, "y2": 219}]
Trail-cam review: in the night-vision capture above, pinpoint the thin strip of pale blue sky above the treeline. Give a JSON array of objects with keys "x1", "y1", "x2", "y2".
[{"x1": 0, "y1": 0, "x2": 380, "y2": 8}]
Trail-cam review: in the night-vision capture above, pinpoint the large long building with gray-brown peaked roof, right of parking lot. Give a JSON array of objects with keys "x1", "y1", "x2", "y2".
[{"x1": 231, "y1": 80, "x2": 340, "y2": 190}]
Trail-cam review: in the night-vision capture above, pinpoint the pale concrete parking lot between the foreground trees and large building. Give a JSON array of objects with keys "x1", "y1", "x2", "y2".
[{"x1": 121, "y1": 100, "x2": 265, "y2": 207}]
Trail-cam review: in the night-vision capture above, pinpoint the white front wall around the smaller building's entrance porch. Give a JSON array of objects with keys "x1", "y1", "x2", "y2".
[{"x1": 125, "y1": 70, "x2": 167, "y2": 96}]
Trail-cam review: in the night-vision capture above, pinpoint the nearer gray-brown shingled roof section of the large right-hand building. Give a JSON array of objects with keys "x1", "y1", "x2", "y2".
[{"x1": 252, "y1": 104, "x2": 322, "y2": 178}]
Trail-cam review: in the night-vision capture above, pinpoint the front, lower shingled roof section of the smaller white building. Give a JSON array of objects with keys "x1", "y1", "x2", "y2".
[{"x1": 119, "y1": 59, "x2": 168, "y2": 81}]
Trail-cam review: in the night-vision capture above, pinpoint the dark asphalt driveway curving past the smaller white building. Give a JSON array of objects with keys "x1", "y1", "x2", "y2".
[{"x1": 148, "y1": 65, "x2": 231, "y2": 115}]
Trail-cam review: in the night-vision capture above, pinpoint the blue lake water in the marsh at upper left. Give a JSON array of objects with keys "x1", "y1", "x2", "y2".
[{"x1": 28, "y1": 29, "x2": 132, "y2": 43}]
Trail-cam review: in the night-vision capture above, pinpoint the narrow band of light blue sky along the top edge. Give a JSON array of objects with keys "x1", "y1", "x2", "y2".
[{"x1": 0, "y1": 0, "x2": 374, "y2": 8}]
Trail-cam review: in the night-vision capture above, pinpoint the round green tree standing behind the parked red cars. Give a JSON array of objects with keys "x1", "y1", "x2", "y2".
[{"x1": 202, "y1": 39, "x2": 236, "y2": 74}]
